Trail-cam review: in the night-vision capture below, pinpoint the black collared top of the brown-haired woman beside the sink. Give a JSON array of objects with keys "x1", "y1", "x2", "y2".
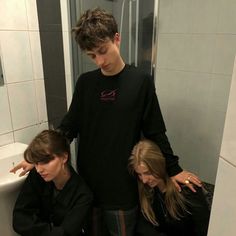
[{"x1": 13, "y1": 168, "x2": 92, "y2": 236}]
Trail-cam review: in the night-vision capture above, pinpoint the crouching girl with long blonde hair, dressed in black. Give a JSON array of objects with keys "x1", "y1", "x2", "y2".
[{"x1": 129, "y1": 140, "x2": 210, "y2": 236}]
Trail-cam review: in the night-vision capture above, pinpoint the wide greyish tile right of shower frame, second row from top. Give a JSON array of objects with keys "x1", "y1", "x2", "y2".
[{"x1": 157, "y1": 34, "x2": 215, "y2": 72}]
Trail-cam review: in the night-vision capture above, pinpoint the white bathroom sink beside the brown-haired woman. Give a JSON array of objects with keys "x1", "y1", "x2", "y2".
[{"x1": 0, "y1": 143, "x2": 27, "y2": 236}]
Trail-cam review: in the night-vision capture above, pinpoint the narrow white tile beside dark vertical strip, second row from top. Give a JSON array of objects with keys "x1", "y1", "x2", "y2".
[{"x1": 29, "y1": 32, "x2": 44, "y2": 79}]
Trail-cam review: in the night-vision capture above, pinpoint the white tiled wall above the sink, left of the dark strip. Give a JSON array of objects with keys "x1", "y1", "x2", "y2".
[{"x1": 0, "y1": 0, "x2": 48, "y2": 146}]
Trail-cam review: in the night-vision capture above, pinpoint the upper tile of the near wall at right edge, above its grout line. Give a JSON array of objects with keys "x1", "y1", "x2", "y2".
[{"x1": 220, "y1": 56, "x2": 236, "y2": 165}]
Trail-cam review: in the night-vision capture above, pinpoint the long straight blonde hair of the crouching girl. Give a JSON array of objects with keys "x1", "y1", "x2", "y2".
[{"x1": 129, "y1": 139, "x2": 187, "y2": 225}]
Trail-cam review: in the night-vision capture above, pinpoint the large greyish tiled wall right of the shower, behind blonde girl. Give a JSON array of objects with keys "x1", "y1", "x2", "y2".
[{"x1": 156, "y1": 0, "x2": 236, "y2": 183}]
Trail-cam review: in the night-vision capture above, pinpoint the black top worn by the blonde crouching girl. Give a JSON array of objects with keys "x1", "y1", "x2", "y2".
[{"x1": 153, "y1": 186, "x2": 210, "y2": 236}]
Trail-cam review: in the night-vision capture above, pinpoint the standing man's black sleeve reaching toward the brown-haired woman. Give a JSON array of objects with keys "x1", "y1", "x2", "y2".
[{"x1": 57, "y1": 76, "x2": 83, "y2": 142}]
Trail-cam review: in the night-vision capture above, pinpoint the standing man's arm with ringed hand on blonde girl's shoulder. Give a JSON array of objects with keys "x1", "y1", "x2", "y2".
[{"x1": 142, "y1": 78, "x2": 201, "y2": 191}]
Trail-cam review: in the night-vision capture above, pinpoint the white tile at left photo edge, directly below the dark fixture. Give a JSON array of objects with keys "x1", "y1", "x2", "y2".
[{"x1": 0, "y1": 86, "x2": 12, "y2": 134}]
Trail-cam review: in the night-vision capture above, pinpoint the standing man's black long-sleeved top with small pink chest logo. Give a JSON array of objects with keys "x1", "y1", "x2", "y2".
[{"x1": 59, "y1": 65, "x2": 182, "y2": 209}]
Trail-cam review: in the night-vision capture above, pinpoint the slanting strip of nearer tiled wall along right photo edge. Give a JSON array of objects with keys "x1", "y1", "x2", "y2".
[{"x1": 208, "y1": 58, "x2": 236, "y2": 236}]
